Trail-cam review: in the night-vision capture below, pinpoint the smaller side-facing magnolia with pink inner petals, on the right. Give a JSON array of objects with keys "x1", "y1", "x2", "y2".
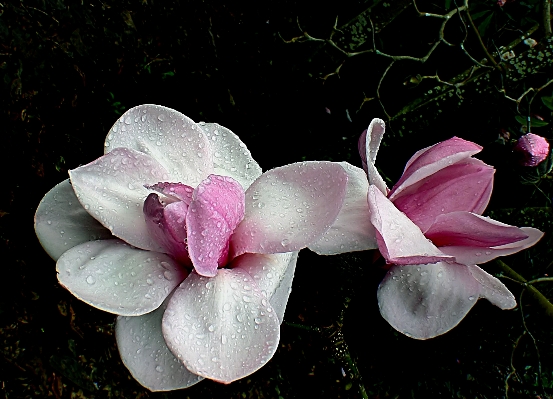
[{"x1": 359, "y1": 119, "x2": 543, "y2": 339}]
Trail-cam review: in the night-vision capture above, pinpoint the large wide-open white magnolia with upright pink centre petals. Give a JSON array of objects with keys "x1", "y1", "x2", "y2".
[{"x1": 35, "y1": 105, "x2": 376, "y2": 391}]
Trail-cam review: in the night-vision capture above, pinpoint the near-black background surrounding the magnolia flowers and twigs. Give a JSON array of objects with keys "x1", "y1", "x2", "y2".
[{"x1": 0, "y1": 0, "x2": 553, "y2": 398}]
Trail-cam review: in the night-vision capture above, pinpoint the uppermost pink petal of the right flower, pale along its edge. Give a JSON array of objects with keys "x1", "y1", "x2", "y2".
[{"x1": 389, "y1": 137, "x2": 482, "y2": 201}]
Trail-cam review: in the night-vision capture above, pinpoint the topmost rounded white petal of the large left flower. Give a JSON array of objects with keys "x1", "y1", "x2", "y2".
[{"x1": 105, "y1": 104, "x2": 213, "y2": 187}]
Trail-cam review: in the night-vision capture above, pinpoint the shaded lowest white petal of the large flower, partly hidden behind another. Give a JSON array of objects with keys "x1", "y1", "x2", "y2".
[{"x1": 115, "y1": 296, "x2": 203, "y2": 391}]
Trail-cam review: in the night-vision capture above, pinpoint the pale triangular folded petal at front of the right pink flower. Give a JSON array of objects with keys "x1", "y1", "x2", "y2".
[{"x1": 368, "y1": 185, "x2": 454, "y2": 265}]
